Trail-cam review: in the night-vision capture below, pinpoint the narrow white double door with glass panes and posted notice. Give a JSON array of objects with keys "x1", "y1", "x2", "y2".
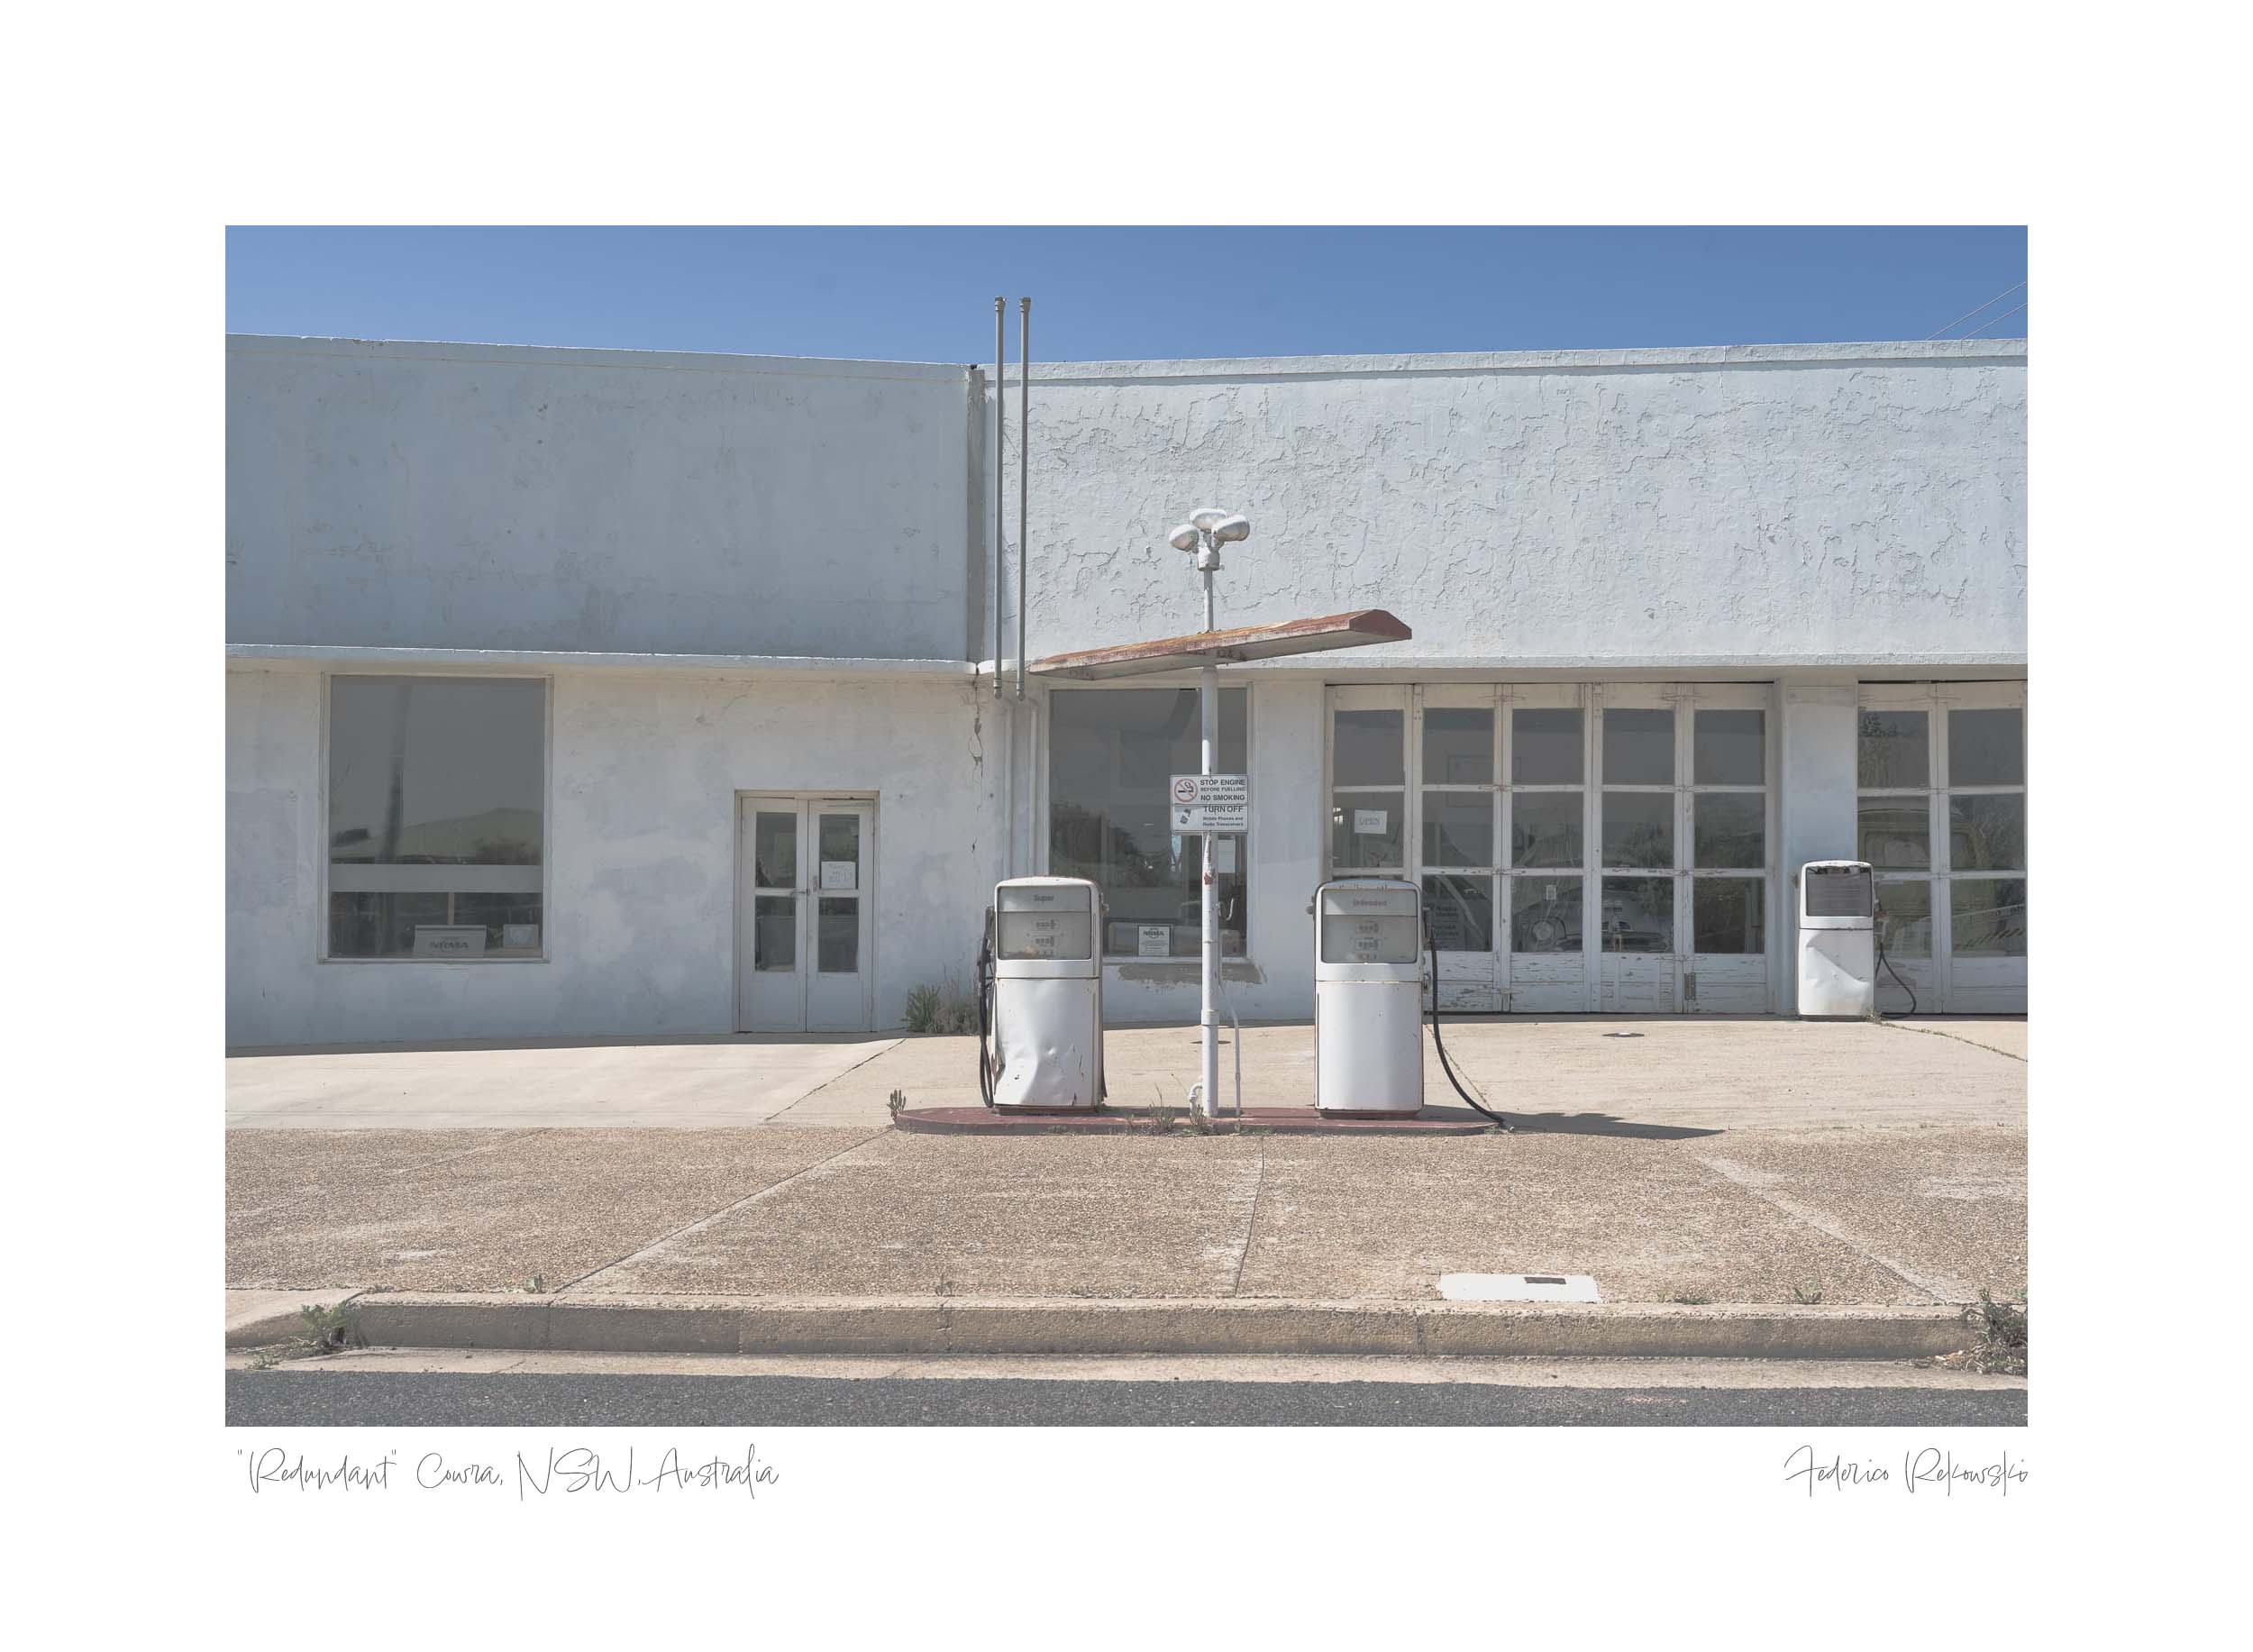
[{"x1": 734, "y1": 793, "x2": 877, "y2": 1032}]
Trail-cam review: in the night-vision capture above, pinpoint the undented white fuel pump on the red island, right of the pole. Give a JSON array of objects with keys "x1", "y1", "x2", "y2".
[{"x1": 1314, "y1": 877, "x2": 1424, "y2": 1118}]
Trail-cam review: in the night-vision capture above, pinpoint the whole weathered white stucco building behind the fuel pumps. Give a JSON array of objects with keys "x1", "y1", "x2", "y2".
[{"x1": 228, "y1": 338, "x2": 2028, "y2": 1048}]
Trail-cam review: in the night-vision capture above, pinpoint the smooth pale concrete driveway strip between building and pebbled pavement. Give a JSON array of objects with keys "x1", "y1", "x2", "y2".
[{"x1": 228, "y1": 1017, "x2": 2026, "y2": 1138}]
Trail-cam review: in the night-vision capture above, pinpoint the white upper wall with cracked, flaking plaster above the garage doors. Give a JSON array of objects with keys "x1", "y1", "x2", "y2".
[{"x1": 1009, "y1": 341, "x2": 2026, "y2": 674}]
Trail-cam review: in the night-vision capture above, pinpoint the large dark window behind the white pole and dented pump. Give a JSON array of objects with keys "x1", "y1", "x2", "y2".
[{"x1": 1048, "y1": 688, "x2": 1253, "y2": 958}]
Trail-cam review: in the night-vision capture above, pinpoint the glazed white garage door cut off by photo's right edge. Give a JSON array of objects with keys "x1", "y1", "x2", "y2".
[{"x1": 1856, "y1": 683, "x2": 2026, "y2": 1014}]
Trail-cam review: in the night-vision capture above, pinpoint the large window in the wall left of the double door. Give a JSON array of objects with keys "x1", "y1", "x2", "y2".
[{"x1": 329, "y1": 676, "x2": 548, "y2": 958}]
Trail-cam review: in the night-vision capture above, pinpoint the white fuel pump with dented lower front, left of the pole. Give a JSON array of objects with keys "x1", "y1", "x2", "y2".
[{"x1": 978, "y1": 877, "x2": 1104, "y2": 1113}]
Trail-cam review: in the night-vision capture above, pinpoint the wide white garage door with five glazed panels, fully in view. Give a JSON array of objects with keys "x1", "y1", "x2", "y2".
[{"x1": 1329, "y1": 683, "x2": 1775, "y2": 1014}]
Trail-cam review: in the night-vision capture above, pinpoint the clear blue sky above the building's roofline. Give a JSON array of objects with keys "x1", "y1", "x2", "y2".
[{"x1": 228, "y1": 228, "x2": 2028, "y2": 361}]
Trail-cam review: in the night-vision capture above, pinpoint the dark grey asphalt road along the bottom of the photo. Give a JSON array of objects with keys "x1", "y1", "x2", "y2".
[{"x1": 228, "y1": 1370, "x2": 2026, "y2": 1428}]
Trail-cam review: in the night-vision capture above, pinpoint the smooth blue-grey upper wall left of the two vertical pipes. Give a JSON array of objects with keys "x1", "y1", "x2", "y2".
[{"x1": 228, "y1": 338, "x2": 985, "y2": 661}]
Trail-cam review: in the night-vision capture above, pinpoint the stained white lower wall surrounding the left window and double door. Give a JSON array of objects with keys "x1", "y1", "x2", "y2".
[{"x1": 228, "y1": 667, "x2": 1005, "y2": 1045}]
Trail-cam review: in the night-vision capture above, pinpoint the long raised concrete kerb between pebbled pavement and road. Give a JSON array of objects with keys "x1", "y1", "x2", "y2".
[{"x1": 342, "y1": 1293, "x2": 1972, "y2": 1359}]
